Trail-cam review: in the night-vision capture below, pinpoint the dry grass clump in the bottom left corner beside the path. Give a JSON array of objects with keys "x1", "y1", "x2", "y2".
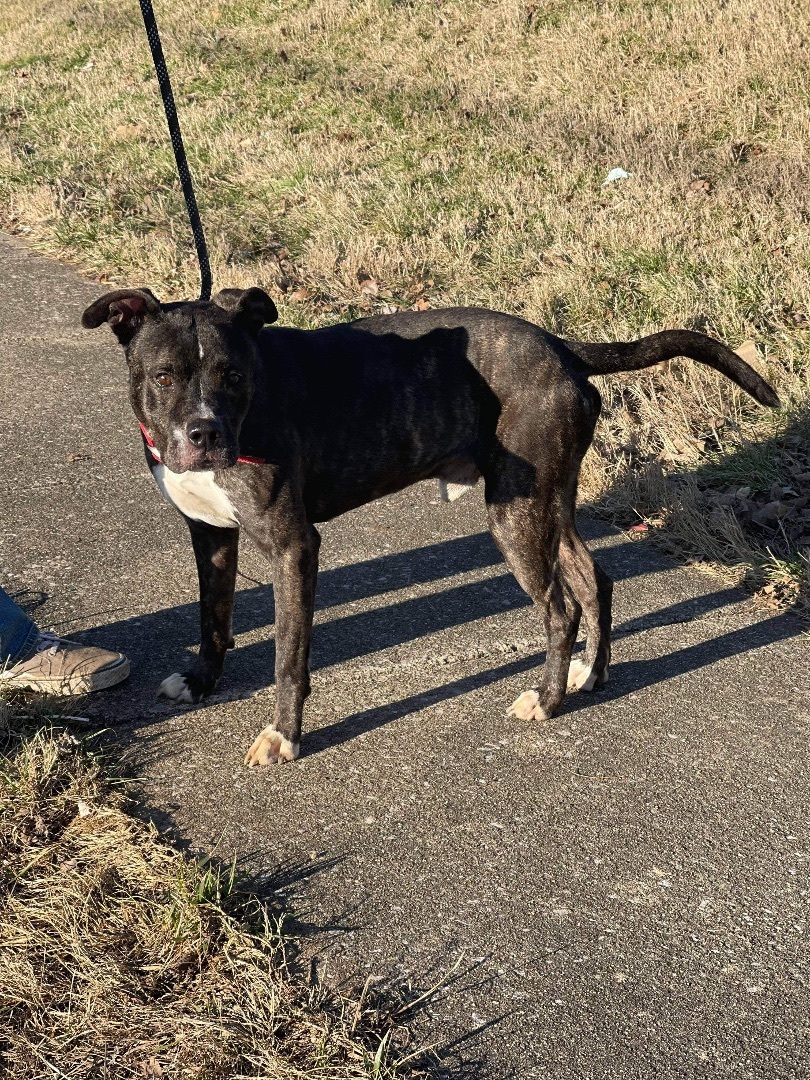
[{"x1": 0, "y1": 701, "x2": 426, "y2": 1080}]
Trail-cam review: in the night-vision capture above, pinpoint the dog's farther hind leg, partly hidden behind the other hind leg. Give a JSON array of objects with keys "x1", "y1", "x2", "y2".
[{"x1": 559, "y1": 522, "x2": 613, "y2": 690}]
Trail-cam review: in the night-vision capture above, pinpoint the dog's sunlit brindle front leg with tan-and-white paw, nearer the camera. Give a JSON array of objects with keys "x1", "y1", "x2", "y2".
[{"x1": 245, "y1": 524, "x2": 321, "y2": 765}]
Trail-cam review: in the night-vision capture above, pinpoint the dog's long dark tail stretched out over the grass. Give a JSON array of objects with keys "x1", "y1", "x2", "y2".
[{"x1": 566, "y1": 330, "x2": 780, "y2": 407}]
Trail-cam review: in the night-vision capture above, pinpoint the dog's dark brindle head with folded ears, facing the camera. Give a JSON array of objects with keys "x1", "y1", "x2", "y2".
[{"x1": 82, "y1": 288, "x2": 278, "y2": 472}]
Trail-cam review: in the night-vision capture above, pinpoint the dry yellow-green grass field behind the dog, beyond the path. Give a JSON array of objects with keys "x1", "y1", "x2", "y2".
[{"x1": 0, "y1": 0, "x2": 810, "y2": 609}]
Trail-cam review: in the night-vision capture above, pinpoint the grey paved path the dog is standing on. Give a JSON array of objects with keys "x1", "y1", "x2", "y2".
[{"x1": 0, "y1": 238, "x2": 810, "y2": 1080}]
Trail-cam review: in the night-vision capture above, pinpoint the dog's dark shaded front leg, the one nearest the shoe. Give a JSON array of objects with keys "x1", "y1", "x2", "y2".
[{"x1": 158, "y1": 515, "x2": 239, "y2": 703}]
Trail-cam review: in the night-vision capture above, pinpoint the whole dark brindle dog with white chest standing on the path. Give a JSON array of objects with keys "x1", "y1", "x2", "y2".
[{"x1": 82, "y1": 288, "x2": 779, "y2": 766}]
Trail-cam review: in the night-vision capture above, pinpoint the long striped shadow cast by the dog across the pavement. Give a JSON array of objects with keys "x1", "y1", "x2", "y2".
[{"x1": 77, "y1": 522, "x2": 801, "y2": 754}]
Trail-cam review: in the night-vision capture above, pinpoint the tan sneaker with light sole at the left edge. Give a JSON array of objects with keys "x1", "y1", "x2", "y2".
[{"x1": 0, "y1": 633, "x2": 130, "y2": 698}]
